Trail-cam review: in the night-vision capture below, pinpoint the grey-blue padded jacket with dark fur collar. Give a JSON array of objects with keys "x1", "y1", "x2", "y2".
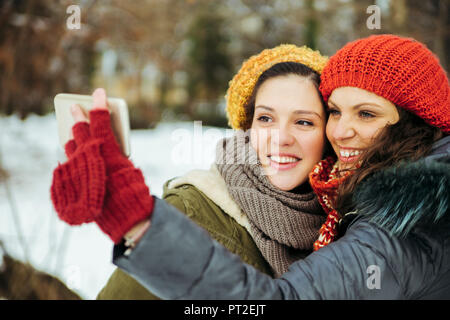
[{"x1": 113, "y1": 137, "x2": 450, "y2": 299}]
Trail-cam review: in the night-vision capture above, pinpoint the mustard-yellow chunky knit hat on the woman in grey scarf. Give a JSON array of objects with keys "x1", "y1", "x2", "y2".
[{"x1": 225, "y1": 44, "x2": 328, "y2": 130}]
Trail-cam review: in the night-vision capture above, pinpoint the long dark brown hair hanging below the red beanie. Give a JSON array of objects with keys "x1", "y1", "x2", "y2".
[{"x1": 334, "y1": 107, "x2": 444, "y2": 216}]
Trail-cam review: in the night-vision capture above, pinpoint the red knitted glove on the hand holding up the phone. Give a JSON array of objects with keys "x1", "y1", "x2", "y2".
[{"x1": 51, "y1": 110, "x2": 154, "y2": 243}]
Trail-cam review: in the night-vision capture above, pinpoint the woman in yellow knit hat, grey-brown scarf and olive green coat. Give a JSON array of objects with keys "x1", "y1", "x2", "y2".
[{"x1": 57, "y1": 44, "x2": 328, "y2": 299}]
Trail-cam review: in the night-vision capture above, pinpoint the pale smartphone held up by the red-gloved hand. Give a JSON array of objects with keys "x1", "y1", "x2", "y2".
[{"x1": 54, "y1": 93, "x2": 131, "y2": 157}]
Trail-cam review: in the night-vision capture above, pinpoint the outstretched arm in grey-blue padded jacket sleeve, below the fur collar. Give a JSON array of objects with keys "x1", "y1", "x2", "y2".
[{"x1": 113, "y1": 198, "x2": 403, "y2": 300}]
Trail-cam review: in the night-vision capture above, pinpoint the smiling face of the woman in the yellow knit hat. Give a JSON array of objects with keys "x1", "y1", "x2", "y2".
[{"x1": 250, "y1": 74, "x2": 326, "y2": 191}]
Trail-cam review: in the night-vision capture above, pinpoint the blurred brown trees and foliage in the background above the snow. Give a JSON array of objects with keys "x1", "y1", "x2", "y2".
[{"x1": 0, "y1": 0, "x2": 450, "y2": 128}]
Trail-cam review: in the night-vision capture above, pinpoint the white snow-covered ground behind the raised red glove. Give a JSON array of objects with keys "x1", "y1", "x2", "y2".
[{"x1": 0, "y1": 114, "x2": 231, "y2": 299}]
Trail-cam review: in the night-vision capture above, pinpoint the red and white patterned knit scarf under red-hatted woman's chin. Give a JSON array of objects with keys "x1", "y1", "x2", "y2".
[{"x1": 309, "y1": 157, "x2": 352, "y2": 251}]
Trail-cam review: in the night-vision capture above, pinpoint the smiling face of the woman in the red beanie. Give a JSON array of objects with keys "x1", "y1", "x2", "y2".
[{"x1": 326, "y1": 87, "x2": 399, "y2": 170}]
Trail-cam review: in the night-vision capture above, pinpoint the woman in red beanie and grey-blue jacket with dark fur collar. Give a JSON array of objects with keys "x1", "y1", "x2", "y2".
[{"x1": 51, "y1": 35, "x2": 450, "y2": 299}]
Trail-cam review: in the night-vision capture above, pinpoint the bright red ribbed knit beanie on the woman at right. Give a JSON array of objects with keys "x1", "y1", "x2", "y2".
[{"x1": 320, "y1": 35, "x2": 450, "y2": 133}]
